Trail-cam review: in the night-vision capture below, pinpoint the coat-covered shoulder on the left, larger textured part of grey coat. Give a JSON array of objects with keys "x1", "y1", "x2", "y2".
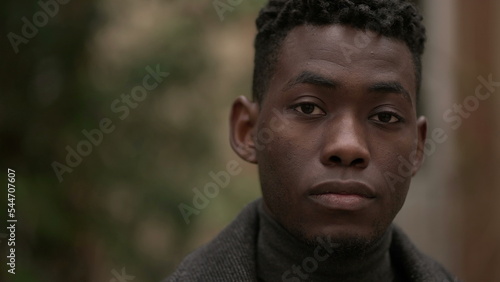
[{"x1": 165, "y1": 199, "x2": 261, "y2": 282}]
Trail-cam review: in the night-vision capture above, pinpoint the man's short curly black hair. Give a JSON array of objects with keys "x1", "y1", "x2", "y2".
[{"x1": 252, "y1": 0, "x2": 426, "y2": 103}]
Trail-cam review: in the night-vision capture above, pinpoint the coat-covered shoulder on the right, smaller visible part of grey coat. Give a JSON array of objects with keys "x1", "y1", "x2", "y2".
[{"x1": 390, "y1": 226, "x2": 459, "y2": 282}]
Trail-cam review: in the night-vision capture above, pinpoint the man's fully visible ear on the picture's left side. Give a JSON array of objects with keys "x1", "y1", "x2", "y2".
[{"x1": 229, "y1": 96, "x2": 259, "y2": 164}]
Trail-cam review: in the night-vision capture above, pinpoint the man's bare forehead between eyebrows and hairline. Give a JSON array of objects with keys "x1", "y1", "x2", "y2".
[{"x1": 270, "y1": 25, "x2": 416, "y2": 99}]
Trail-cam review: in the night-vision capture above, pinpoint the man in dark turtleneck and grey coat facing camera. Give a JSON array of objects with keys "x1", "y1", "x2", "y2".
[{"x1": 168, "y1": 0, "x2": 455, "y2": 282}]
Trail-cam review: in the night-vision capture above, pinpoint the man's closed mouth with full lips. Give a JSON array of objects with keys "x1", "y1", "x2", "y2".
[{"x1": 308, "y1": 181, "x2": 376, "y2": 211}]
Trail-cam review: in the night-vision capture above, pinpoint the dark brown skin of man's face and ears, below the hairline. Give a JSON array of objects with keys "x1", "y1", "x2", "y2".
[{"x1": 231, "y1": 25, "x2": 426, "y2": 247}]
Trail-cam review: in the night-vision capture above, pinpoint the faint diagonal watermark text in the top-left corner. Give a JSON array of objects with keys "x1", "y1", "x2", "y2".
[{"x1": 7, "y1": 0, "x2": 71, "y2": 54}]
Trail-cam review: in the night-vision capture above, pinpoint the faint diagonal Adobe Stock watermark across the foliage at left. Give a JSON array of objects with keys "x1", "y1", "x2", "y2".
[{"x1": 52, "y1": 65, "x2": 170, "y2": 183}]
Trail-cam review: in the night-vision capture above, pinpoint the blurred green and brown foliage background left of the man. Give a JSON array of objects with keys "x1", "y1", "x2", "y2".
[{"x1": 0, "y1": 0, "x2": 265, "y2": 281}]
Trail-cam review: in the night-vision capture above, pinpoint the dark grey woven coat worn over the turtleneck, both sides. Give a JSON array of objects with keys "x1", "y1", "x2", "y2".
[{"x1": 165, "y1": 199, "x2": 458, "y2": 282}]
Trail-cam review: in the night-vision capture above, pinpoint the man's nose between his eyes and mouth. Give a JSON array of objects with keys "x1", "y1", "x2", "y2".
[{"x1": 321, "y1": 117, "x2": 370, "y2": 169}]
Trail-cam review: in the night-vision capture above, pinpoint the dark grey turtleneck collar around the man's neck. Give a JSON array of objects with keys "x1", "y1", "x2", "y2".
[{"x1": 257, "y1": 202, "x2": 395, "y2": 282}]
